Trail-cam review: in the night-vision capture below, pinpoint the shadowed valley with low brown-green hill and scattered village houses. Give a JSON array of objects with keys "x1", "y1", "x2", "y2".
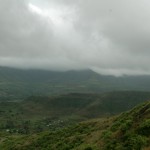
[{"x1": 0, "y1": 91, "x2": 150, "y2": 134}]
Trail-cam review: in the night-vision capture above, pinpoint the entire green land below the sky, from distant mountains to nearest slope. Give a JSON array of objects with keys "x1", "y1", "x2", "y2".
[{"x1": 0, "y1": 67, "x2": 150, "y2": 150}]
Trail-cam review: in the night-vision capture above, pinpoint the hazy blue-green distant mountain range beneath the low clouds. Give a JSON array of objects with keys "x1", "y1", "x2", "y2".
[{"x1": 0, "y1": 67, "x2": 150, "y2": 100}]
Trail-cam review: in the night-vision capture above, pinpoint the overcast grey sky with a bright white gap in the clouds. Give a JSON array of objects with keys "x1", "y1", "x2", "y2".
[{"x1": 0, "y1": 0, "x2": 150, "y2": 76}]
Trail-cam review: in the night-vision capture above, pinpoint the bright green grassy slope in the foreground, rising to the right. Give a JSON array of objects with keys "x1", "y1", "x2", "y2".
[{"x1": 0, "y1": 101, "x2": 150, "y2": 150}]
